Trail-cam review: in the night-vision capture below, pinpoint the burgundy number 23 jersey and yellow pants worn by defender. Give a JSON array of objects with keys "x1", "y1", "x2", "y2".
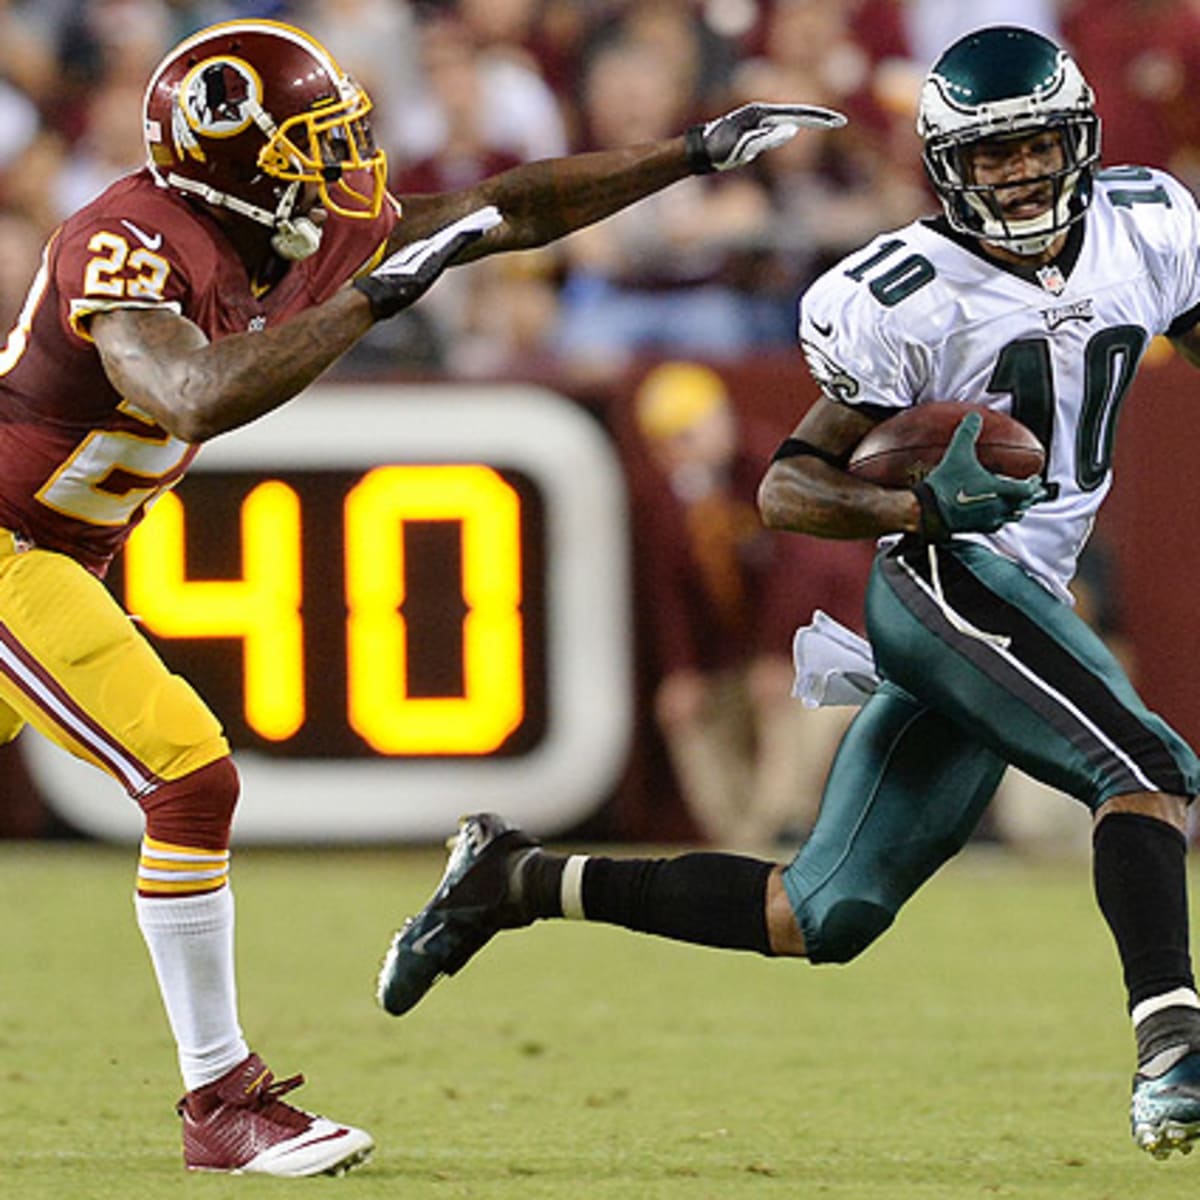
[{"x1": 0, "y1": 170, "x2": 396, "y2": 796}]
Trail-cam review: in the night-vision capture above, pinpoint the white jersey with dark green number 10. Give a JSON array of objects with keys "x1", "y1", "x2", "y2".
[{"x1": 800, "y1": 167, "x2": 1200, "y2": 599}]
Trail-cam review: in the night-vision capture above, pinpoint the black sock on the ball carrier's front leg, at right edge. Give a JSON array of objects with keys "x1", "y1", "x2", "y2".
[{"x1": 1092, "y1": 812, "x2": 1195, "y2": 1012}]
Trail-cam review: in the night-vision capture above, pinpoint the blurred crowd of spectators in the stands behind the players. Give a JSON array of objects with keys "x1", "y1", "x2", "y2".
[{"x1": 0, "y1": 0, "x2": 1200, "y2": 377}]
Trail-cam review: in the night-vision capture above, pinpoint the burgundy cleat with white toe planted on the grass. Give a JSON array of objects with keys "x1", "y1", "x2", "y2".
[{"x1": 176, "y1": 1054, "x2": 374, "y2": 1177}]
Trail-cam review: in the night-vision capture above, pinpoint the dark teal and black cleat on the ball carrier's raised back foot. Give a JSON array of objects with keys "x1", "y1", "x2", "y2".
[{"x1": 376, "y1": 812, "x2": 539, "y2": 1016}]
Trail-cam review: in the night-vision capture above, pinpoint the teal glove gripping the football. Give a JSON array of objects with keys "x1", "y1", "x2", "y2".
[{"x1": 913, "y1": 413, "x2": 1046, "y2": 541}]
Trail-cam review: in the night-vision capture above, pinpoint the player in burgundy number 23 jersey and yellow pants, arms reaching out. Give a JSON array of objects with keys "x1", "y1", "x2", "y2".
[{"x1": 0, "y1": 20, "x2": 842, "y2": 1176}]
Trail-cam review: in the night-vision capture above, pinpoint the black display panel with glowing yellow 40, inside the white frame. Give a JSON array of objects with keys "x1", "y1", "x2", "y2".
[{"x1": 114, "y1": 463, "x2": 545, "y2": 757}]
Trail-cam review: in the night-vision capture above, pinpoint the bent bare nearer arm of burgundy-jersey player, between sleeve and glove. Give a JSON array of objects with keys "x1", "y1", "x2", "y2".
[{"x1": 89, "y1": 288, "x2": 373, "y2": 443}]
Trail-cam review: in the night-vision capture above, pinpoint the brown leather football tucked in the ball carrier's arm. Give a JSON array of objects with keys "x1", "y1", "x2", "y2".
[{"x1": 847, "y1": 401, "x2": 1045, "y2": 487}]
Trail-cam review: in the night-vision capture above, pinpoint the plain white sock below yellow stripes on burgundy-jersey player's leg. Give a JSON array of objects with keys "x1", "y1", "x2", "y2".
[{"x1": 134, "y1": 886, "x2": 250, "y2": 1092}]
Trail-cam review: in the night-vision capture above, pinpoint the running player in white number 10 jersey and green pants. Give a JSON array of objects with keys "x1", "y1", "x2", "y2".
[{"x1": 379, "y1": 26, "x2": 1200, "y2": 1157}]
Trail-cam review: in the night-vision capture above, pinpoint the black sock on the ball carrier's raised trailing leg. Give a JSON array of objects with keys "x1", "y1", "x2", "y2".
[{"x1": 582, "y1": 853, "x2": 773, "y2": 954}]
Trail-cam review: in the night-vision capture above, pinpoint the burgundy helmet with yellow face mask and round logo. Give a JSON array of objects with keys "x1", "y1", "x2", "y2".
[{"x1": 144, "y1": 20, "x2": 388, "y2": 259}]
